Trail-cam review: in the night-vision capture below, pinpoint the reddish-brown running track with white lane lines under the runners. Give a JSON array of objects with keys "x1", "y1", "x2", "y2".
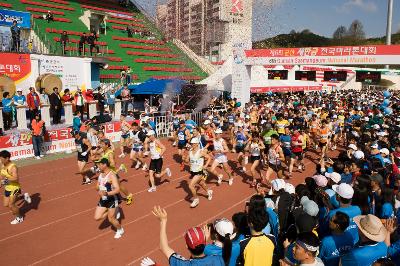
[{"x1": 0, "y1": 140, "x2": 332, "y2": 266}]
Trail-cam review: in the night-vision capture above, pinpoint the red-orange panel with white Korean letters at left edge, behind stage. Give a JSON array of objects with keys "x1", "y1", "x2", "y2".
[{"x1": 0, "y1": 53, "x2": 31, "y2": 81}]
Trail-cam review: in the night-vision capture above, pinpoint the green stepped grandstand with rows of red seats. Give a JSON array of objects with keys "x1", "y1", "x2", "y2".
[{"x1": 0, "y1": 0, "x2": 207, "y2": 83}]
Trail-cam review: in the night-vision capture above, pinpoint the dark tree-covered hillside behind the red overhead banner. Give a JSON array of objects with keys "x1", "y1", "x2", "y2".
[{"x1": 253, "y1": 20, "x2": 400, "y2": 49}]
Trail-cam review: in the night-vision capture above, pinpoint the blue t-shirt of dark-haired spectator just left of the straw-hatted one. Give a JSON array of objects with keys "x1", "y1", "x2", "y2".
[{"x1": 318, "y1": 232, "x2": 354, "y2": 266}]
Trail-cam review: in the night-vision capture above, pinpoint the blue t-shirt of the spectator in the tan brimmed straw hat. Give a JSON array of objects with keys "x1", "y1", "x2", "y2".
[{"x1": 341, "y1": 242, "x2": 388, "y2": 266}]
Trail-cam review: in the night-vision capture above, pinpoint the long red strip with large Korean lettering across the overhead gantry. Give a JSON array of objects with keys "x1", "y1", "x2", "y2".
[{"x1": 245, "y1": 45, "x2": 400, "y2": 57}]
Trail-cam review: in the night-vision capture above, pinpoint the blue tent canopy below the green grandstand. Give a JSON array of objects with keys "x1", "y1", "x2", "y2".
[{"x1": 128, "y1": 78, "x2": 187, "y2": 94}]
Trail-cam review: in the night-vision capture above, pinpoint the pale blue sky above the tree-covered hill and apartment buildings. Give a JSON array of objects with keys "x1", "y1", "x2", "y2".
[{"x1": 136, "y1": 0, "x2": 400, "y2": 40}]
